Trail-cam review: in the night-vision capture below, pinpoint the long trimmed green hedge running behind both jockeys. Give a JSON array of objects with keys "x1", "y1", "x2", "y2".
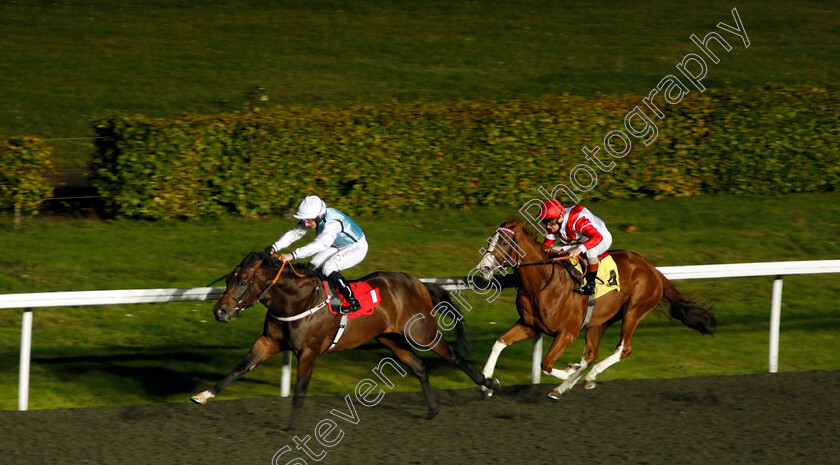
[{"x1": 92, "y1": 87, "x2": 840, "y2": 219}]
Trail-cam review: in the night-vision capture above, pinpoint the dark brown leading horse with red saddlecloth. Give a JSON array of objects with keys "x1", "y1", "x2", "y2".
[{"x1": 192, "y1": 252, "x2": 499, "y2": 429}]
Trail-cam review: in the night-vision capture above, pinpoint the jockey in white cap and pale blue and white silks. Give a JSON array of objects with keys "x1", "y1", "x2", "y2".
[{"x1": 267, "y1": 195, "x2": 368, "y2": 314}]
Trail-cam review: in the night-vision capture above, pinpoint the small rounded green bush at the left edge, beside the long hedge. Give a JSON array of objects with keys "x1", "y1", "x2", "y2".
[{"x1": 0, "y1": 137, "x2": 55, "y2": 214}]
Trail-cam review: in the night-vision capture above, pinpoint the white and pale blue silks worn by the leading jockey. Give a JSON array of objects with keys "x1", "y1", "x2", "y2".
[{"x1": 271, "y1": 207, "x2": 368, "y2": 276}]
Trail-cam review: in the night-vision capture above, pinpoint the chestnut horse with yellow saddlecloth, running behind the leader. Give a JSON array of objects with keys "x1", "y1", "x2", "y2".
[{"x1": 477, "y1": 220, "x2": 715, "y2": 400}]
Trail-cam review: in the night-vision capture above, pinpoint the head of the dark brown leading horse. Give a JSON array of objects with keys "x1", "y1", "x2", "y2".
[{"x1": 213, "y1": 252, "x2": 267, "y2": 323}]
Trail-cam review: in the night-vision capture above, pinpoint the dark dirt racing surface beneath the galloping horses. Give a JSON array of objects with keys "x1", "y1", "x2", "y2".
[{"x1": 0, "y1": 371, "x2": 840, "y2": 465}]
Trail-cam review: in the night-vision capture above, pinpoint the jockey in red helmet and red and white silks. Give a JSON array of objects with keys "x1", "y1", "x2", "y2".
[{"x1": 539, "y1": 199, "x2": 612, "y2": 295}]
